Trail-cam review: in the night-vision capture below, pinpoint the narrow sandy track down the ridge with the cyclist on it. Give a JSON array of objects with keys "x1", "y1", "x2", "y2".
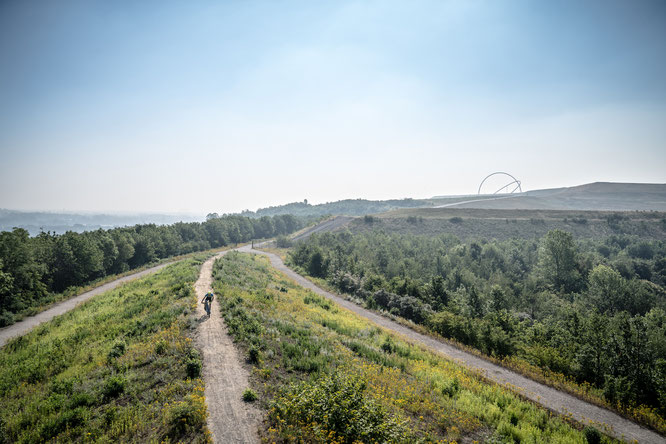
[{"x1": 194, "y1": 252, "x2": 262, "y2": 444}]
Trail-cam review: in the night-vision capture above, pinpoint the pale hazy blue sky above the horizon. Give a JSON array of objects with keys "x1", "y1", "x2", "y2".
[{"x1": 0, "y1": 0, "x2": 666, "y2": 213}]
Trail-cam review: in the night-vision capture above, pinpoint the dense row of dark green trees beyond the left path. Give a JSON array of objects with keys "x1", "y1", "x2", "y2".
[{"x1": 0, "y1": 215, "x2": 305, "y2": 326}]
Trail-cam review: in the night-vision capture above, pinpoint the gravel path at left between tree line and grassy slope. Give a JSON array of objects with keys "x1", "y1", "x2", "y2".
[{"x1": 0, "y1": 262, "x2": 173, "y2": 347}]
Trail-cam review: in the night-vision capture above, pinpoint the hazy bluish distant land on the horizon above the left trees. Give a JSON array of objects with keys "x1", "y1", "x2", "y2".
[{"x1": 0, "y1": 208, "x2": 203, "y2": 236}]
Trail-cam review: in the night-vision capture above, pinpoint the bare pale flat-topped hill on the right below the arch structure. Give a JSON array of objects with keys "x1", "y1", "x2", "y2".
[{"x1": 436, "y1": 182, "x2": 666, "y2": 211}]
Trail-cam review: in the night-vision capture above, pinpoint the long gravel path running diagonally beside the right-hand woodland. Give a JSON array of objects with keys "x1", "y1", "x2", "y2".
[{"x1": 243, "y1": 246, "x2": 666, "y2": 444}]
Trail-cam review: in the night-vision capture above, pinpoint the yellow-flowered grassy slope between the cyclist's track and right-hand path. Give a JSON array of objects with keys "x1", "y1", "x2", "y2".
[{"x1": 214, "y1": 253, "x2": 613, "y2": 443}]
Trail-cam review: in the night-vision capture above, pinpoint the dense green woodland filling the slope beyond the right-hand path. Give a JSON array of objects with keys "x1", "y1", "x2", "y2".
[{"x1": 289, "y1": 230, "x2": 666, "y2": 417}]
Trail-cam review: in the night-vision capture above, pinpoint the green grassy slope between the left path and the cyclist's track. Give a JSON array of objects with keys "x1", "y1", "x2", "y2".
[{"x1": 0, "y1": 254, "x2": 209, "y2": 442}]
